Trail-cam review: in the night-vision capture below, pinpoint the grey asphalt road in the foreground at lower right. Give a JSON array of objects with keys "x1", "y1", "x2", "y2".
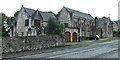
[{"x1": 18, "y1": 39, "x2": 118, "y2": 58}]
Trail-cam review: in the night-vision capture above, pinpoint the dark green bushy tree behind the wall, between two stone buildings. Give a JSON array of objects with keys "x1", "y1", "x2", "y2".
[{"x1": 45, "y1": 17, "x2": 64, "y2": 35}]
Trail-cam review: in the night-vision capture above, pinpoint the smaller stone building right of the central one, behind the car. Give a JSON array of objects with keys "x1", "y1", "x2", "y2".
[{"x1": 95, "y1": 17, "x2": 113, "y2": 37}]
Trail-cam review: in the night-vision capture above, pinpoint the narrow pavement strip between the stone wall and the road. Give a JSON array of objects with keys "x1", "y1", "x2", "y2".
[{"x1": 2, "y1": 38, "x2": 120, "y2": 59}]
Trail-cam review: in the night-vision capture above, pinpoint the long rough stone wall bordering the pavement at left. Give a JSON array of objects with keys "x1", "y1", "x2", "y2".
[{"x1": 2, "y1": 35, "x2": 65, "y2": 53}]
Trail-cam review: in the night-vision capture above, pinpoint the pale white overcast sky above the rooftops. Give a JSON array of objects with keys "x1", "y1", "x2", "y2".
[{"x1": 0, "y1": 0, "x2": 120, "y2": 21}]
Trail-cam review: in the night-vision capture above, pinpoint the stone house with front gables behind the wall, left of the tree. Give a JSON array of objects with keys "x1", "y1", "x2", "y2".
[{"x1": 10, "y1": 6, "x2": 56, "y2": 37}]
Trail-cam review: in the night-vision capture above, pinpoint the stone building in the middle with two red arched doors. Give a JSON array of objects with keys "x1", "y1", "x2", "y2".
[{"x1": 57, "y1": 7, "x2": 95, "y2": 42}]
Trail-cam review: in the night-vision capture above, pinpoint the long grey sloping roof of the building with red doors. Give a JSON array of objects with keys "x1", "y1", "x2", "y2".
[{"x1": 63, "y1": 7, "x2": 94, "y2": 20}]
